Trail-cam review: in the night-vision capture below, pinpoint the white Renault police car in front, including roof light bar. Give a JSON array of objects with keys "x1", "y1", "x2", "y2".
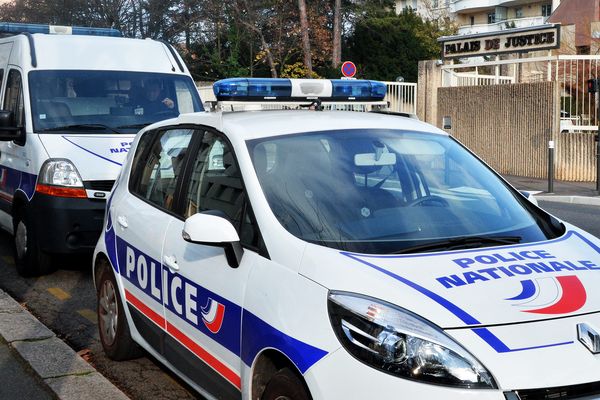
[{"x1": 93, "y1": 79, "x2": 600, "y2": 400}]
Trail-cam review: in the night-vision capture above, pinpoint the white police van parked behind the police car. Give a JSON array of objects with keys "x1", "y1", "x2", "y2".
[{"x1": 0, "y1": 23, "x2": 202, "y2": 275}]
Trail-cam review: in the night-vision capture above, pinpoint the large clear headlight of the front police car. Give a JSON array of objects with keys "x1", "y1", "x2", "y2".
[{"x1": 328, "y1": 292, "x2": 497, "y2": 389}]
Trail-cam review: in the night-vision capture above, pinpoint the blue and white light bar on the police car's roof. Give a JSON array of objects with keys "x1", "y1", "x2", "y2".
[{"x1": 213, "y1": 78, "x2": 387, "y2": 101}]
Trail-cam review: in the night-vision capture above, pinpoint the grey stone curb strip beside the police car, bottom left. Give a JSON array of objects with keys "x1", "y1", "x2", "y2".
[{"x1": 0, "y1": 290, "x2": 129, "y2": 400}]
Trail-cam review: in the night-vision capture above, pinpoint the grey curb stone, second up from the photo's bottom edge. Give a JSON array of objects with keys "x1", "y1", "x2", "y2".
[{"x1": 12, "y1": 337, "x2": 95, "y2": 379}]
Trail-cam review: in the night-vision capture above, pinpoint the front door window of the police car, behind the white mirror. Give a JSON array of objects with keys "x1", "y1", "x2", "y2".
[{"x1": 183, "y1": 131, "x2": 260, "y2": 247}]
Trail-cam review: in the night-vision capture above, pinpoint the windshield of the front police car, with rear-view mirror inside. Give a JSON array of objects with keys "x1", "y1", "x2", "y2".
[{"x1": 248, "y1": 129, "x2": 562, "y2": 254}]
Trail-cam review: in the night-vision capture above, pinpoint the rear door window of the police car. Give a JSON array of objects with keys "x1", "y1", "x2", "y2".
[{"x1": 132, "y1": 129, "x2": 194, "y2": 211}]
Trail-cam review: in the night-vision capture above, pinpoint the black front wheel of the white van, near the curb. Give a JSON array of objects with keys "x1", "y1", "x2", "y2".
[{"x1": 13, "y1": 209, "x2": 53, "y2": 277}]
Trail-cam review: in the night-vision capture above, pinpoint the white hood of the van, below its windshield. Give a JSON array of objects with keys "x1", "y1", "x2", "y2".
[{"x1": 39, "y1": 134, "x2": 135, "y2": 181}]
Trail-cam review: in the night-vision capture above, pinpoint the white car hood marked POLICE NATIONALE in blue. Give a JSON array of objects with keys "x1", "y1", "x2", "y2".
[{"x1": 300, "y1": 226, "x2": 600, "y2": 329}]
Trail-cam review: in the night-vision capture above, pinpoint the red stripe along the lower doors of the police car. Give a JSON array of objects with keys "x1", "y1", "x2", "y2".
[{"x1": 125, "y1": 290, "x2": 242, "y2": 390}]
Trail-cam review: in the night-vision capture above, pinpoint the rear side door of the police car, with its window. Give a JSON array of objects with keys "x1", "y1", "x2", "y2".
[{"x1": 111, "y1": 128, "x2": 194, "y2": 352}]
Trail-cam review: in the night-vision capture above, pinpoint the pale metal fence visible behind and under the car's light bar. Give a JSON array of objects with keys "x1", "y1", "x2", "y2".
[{"x1": 198, "y1": 82, "x2": 417, "y2": 114}]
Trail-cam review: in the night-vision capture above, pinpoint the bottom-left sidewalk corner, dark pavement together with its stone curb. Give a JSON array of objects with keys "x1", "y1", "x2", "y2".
[{"x1": 0, "y1": 290, "x2": 128, "y2": 400}]
